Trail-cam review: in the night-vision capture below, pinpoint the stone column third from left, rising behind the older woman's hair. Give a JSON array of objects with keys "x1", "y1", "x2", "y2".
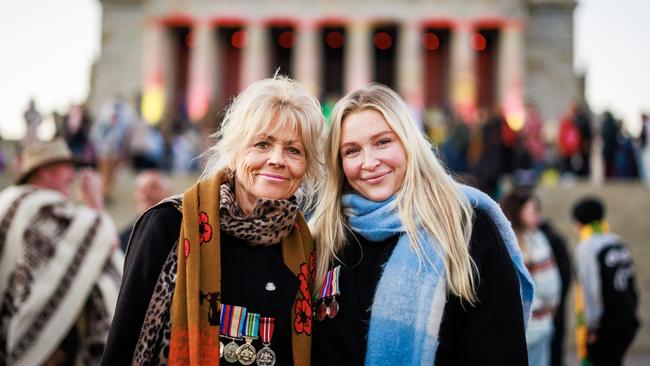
[{"x1": 239, "y1": 20, "x2": 269, "y2": 90}]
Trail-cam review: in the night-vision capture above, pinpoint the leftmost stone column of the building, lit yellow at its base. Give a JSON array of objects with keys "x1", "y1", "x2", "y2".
[{"x1": 142, "y1": 21, "x2": 173, "y2": 124}]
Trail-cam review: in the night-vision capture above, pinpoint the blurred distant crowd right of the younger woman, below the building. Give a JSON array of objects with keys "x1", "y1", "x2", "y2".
[{"x1": 424, "y1": 103, "x2": 650, "y2": 197}]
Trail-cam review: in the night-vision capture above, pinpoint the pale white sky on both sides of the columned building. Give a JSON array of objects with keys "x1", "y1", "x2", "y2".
[{"x1": 0, "y1": 0, "x2": 650, "y2": 138}]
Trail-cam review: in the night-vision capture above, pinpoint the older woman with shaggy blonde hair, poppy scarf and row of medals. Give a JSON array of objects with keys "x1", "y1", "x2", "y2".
[{"x1": 102, "y1": 78, "x2": 323, "y2": 365}]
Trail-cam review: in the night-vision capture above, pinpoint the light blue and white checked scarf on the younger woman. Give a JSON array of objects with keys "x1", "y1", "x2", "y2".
[{"x1": 341, "y1": 186, "x2": 533, "y2": 365}]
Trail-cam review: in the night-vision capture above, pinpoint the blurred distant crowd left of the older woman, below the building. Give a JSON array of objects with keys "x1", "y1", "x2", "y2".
[{"x1": 0, "y1": 98, "x2": 205, "y2": 204}]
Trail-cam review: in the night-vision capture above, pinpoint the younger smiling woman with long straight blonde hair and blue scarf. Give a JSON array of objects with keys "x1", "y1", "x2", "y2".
[{"x1": 310, "y1": 84, "x2": 533, "y2": 365}]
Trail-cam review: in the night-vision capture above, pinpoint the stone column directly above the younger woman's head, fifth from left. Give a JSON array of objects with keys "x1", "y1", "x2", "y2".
[{"x1": 344, "y1": 21, "x2": 374, "y2": 93}]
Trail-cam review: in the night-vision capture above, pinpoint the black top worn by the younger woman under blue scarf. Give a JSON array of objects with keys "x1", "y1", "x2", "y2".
[{"x1": 312, "y1": 210, "x2": 528, "y2": 366}]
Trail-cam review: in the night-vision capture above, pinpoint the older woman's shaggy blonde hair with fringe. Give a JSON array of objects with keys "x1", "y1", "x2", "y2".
[{"x1": 199, "y1": 76, "x2": 324, "y2": 208}]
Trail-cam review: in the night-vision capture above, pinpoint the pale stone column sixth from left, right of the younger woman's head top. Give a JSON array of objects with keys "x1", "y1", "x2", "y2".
[{"x1": 397, "y1": 21, "x2": 424, "y2": 129}]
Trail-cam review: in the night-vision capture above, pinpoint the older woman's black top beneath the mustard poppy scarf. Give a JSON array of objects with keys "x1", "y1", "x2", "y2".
[{"x1": 102, "y1": 205, "x2": 299, "y2": 365}]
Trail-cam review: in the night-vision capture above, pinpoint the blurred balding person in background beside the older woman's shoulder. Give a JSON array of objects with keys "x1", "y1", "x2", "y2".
[{"x1": 120, "y1": 169, "x2": 171, "y2": 252}]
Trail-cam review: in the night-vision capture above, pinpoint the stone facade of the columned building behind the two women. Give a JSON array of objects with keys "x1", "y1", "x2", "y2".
[{"x1": 89, "y1": 0, "x2": 579, "y2": 127}]
